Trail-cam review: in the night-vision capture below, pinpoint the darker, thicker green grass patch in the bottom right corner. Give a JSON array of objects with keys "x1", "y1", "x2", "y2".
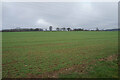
[{"x1": 59, "y1": 56, "x2": 118, "y2": 78}]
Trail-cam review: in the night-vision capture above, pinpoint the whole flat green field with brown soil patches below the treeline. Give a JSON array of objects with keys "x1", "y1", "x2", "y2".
[{"x1": 2, "y1": 31, "x2": 118, "y2": 78}]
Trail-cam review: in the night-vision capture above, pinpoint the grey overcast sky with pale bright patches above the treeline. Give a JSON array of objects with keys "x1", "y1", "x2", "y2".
[{"x1": 2, "y1": 2, "x2": 118, "y2": 29}]
